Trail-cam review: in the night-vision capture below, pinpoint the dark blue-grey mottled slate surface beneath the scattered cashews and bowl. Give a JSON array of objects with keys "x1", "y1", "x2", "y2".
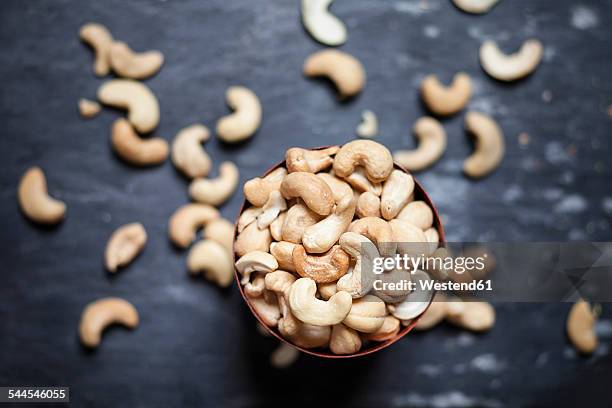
[{"x1": 0, "y1": 0, "x2": 612, "y2": 407}]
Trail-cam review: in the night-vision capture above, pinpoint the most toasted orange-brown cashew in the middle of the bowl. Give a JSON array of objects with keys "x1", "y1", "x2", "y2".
[{"x1": 293, "y1": 245, "x2": 350, "y2": 283}]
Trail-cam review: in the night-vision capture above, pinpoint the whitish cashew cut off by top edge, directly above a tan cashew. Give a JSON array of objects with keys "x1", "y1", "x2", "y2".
[{"x1": 302, "y1": 0, "x2": 347, "y2": 47}]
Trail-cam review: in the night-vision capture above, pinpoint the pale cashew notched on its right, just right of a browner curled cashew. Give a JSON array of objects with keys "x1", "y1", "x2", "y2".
[{"x1": 172, "y1": 123, "x2": 212, "y2": 178}]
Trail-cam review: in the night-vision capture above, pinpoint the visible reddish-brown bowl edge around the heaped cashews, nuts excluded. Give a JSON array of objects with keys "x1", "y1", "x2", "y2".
[{"x1": 234, "y1": 146, "x2": 445, "y2": 358}]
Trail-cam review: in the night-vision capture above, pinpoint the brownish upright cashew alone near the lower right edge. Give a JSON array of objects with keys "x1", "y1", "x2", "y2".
[{"x1": 566, "y1": 299, "x2": 598, "y2": 354}]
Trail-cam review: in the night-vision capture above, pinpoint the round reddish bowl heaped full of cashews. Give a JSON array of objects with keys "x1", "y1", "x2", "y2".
[{"x1": 234, "y1": 140, "x2": 444, "y2": 358}]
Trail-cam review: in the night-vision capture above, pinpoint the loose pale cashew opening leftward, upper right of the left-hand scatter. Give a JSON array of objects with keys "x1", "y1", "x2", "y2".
[{"x1": 217, "y1": 86, "x2": 262, "y2": 143}]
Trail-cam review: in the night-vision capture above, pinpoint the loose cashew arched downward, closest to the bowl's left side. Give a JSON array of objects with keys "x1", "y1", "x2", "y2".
[{"x1": 187, "y1": 239, "x2": 234, "y2": 288}]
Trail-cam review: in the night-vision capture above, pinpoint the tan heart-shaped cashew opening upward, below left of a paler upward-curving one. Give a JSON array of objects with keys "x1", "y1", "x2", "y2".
[{"x1": 421, "y1": 72, "x2": 472, "y2": 116}]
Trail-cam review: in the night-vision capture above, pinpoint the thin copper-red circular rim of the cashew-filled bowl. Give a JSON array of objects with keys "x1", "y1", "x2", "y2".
[{"x1": 232, "y1": 145, "x2": 446, "y2": 359}]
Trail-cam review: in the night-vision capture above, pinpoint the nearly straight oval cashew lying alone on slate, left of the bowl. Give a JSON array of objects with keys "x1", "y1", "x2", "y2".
[{"x1": 104, "y1": 222, "x2": 147, "y2": 272}]
